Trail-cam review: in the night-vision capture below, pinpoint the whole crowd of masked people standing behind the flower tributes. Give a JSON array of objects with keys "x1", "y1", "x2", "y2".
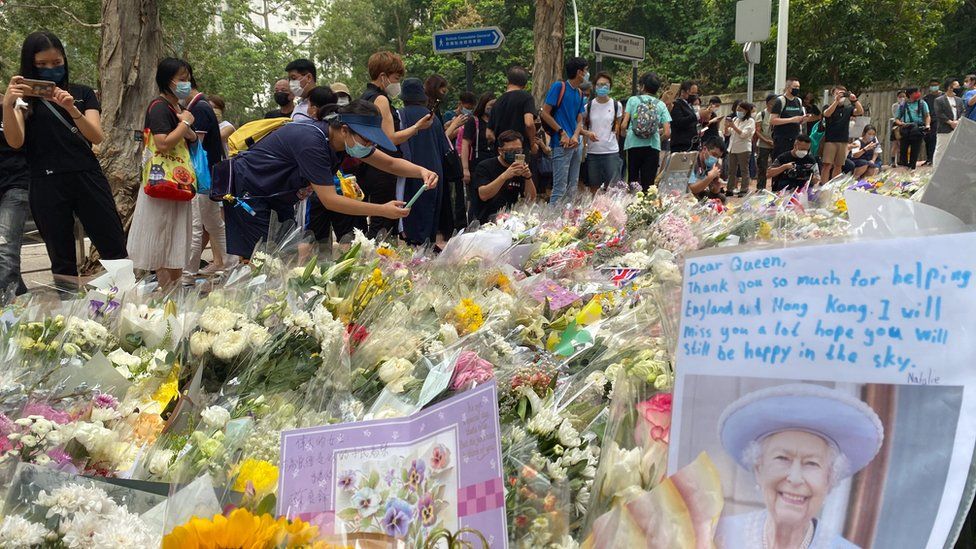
[{"x1": 0, "y1": 28, "x2": 976, "y2": 293}]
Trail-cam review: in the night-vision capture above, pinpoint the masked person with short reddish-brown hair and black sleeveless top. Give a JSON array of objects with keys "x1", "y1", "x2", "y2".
[{"x1": 357, "y1": 51, "x2": 434, "y2": 237}]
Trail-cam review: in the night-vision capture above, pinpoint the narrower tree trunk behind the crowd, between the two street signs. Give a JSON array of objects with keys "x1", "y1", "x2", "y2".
[{"x1": 532, "y1": 0, "x2": 566, "y2": 105}]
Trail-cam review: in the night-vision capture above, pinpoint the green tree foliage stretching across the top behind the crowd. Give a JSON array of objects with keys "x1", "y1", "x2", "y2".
[{"x1": 0, "y1": 0, "x2": 976, "y2": 120}]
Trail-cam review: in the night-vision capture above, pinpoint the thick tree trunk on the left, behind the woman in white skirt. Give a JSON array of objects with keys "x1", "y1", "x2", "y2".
[{"x1": 98, "y1": 0, "x2": 163, "y2": 241}]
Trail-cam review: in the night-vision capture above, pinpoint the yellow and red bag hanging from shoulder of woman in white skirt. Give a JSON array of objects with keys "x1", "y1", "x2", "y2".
[{"x1": 142, "y1": 99, "x2": 197, "y2": 202}]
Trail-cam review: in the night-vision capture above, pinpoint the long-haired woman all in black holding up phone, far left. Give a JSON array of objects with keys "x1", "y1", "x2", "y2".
[{"x1": 3, "y1": 32, "x2": 126, "y2": 279}]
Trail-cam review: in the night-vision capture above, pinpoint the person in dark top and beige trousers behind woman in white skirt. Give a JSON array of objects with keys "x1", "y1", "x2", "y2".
[{"x1": 184, "y1": 67, "x2": 227, "y2": 284}]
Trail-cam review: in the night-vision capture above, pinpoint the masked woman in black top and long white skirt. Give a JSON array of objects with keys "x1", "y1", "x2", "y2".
[{"x1": 129, "y1": 57, "x2": 197, "y2": 287}]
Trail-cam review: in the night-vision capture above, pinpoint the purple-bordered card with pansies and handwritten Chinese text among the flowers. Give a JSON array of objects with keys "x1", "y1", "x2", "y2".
[{"x1": 278, "y1": 383, "x2": 508, "y2": 547}]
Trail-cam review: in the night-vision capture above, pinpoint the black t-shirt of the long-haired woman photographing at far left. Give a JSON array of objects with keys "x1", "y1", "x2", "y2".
[{"x1": 24, "y1": 84, "x2": 101, "y2": 177}]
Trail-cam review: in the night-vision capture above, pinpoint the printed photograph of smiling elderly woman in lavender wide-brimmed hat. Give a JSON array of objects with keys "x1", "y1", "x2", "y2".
[{"x1": 669, "y1": 375, "x2": 963, "y2": 549}]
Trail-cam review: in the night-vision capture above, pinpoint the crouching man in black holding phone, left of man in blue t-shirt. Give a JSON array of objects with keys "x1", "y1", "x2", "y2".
[{"x1": 471, "y1": 130, "x2": 536, "y2": 223}]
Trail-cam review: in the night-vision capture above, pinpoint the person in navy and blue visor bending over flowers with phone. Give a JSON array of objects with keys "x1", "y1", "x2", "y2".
[{"x1": 221, "y1": 99, "x2": 437, "y2": 258}]
